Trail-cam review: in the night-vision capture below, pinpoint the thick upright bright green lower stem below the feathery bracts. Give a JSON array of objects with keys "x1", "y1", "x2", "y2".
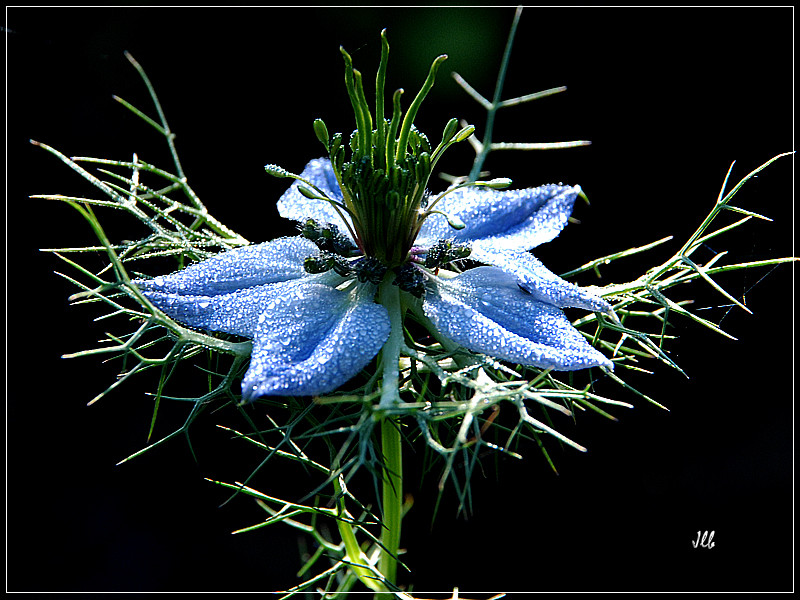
[{"x1": 378, "y1": 417, "x2": 403, "y2": 583}]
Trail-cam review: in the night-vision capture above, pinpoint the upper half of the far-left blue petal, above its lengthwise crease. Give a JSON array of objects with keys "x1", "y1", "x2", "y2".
[{"x1": 133, "y1": 236, "x2": 319, "y2": 296}]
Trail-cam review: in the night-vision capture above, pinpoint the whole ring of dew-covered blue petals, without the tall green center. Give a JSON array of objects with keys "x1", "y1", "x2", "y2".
[{"x1": 134, "y1": 159, "x2": 612, "y2": 400}]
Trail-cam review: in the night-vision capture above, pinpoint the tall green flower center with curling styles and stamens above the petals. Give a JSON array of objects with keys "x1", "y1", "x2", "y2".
[{"x1": 314, "y1": 30, "x2": 475, "y2": 268}]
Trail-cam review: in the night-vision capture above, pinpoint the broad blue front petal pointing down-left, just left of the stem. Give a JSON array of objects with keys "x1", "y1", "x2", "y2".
[{"x1": 242, "y1": 284, "x2": 391, "y2": 400}]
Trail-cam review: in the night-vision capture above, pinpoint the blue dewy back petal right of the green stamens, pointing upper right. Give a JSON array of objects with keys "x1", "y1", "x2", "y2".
[{"x1": 417, "y1": 184, "x2": 581, "y2": 251}]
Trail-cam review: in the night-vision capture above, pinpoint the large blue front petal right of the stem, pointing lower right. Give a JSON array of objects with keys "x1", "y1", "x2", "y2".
[{"x1": 423, "y1": 267, "x2": 612, "y2": 371}]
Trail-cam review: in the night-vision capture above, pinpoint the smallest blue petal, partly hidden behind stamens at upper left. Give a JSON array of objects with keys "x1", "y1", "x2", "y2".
[{"x1": 278, "y1": 158, "x2": 351, "y2": 238}]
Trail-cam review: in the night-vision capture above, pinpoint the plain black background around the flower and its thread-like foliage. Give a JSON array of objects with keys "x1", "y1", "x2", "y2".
[{"x1": 6, "y1": 8, "x2": 794, "y2": 593}]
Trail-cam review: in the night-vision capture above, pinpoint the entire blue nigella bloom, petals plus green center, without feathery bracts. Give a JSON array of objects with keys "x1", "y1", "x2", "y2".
[{"x1": 134, "y1": 32, "x2": 612, "y2": 400}]
